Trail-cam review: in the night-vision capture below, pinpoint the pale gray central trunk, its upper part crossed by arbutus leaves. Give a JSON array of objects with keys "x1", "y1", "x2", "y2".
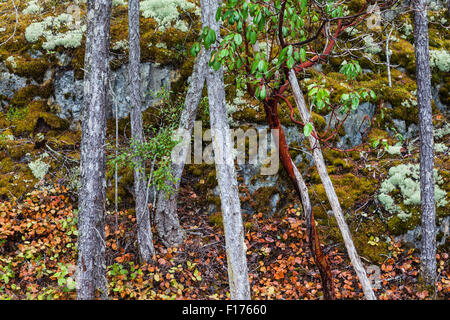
[{"x1": 200, "y1": 0, "x2": 250, "y2": 300}]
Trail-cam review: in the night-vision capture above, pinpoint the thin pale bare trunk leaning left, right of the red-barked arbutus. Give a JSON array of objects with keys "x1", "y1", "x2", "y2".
[{"x1": 289, "y1": 69, "x2": 376, "y2": 300}]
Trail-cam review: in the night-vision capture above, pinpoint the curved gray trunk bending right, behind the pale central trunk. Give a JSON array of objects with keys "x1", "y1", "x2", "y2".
[{"x1": 155, "y1": 50, "x2": 208, "y2": 247}]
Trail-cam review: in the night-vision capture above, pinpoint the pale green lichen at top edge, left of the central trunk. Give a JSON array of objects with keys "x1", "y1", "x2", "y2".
[{"x1": 141, "y1": 0, "x2": 200, "y2": 32}]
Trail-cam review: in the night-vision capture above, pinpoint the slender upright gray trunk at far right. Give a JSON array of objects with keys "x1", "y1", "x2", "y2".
[{"x1": 414, "y1": 0, "x2": 436, "y2": 285}]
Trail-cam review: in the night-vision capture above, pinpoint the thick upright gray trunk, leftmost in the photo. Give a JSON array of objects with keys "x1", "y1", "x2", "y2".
[{"x1": 77, "y1": 0, "x2": 111, "y2": 300}]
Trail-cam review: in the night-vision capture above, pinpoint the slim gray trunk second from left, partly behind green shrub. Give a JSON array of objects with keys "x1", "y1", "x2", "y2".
[{"x1": 128, "y1": 0, "x2": 155, "y2": 262}]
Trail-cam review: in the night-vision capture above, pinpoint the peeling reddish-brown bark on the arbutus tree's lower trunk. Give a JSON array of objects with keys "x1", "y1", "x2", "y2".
[{"x1": 264, "y1": 100, "x2": 336, "y2": 300}]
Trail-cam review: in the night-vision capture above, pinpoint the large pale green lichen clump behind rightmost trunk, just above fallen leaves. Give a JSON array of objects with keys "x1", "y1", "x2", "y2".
[{"x1": 377, "y1": 164, "x2": 447, "y2": 221}]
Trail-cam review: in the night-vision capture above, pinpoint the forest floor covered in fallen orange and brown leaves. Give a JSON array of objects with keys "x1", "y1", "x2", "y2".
[{"x1": 0, "y1": 182, "x2": 450, "y2": 300}]
